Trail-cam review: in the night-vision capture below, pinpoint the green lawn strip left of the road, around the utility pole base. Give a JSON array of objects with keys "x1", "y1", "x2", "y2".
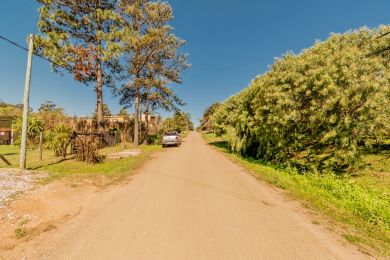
[{"x1": 0, "y1": 145, "x2": 161, "y2": 178}]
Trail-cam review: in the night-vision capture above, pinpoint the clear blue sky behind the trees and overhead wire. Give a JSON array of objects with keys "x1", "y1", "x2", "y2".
[{"x1": 0, "y1": 0, "x2": 390, "y2": 123}]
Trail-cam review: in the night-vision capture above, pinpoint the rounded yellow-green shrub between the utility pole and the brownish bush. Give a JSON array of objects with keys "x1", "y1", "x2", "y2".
[{"x1": 46, "y1": 124, "x2": 73, "y2": 158}]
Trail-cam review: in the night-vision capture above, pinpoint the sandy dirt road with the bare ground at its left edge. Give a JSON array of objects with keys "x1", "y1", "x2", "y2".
[{"x1": 0, "y1": 133, "x2": 368, "y2": 260}]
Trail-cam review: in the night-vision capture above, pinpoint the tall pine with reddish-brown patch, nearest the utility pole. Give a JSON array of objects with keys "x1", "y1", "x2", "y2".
[{"x1": 35, "y1": 0, "x2": 123, "y2": 131}]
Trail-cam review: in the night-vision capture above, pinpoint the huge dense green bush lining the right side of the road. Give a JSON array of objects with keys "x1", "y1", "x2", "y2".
[{"x1": 212, "y1": 28, "x2": 390, "y2": 172}]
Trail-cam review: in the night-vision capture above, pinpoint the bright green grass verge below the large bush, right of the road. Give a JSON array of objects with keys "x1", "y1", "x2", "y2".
[{"x1": 203, "y1": 133, "x2": 390, "y2": 256}]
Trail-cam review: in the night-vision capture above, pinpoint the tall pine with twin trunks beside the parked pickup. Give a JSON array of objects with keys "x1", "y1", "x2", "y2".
[{"x1": 117, "y1": 0, "x2": 189, "y2": 145}]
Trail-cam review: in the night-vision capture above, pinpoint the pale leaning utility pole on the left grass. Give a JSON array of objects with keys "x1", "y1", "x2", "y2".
[{"x1": 20, "y1": 34, "x2": 34, "y2": 170}]
